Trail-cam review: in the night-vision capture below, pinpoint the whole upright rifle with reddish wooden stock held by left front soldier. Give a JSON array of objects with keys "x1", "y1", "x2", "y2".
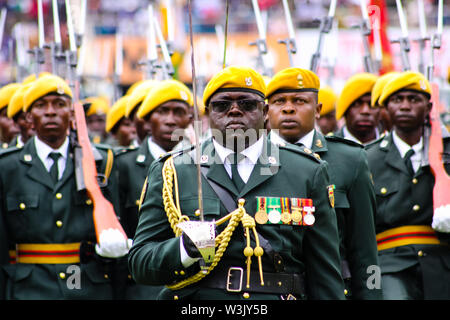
[{"x1": 66, "y1": 0, "x2": 128, "y2": 243}]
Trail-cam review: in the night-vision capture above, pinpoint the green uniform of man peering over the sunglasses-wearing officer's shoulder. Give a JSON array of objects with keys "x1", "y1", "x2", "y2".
[{"x1": 271, "y1": 130, "x2": 382, "y2": 299}]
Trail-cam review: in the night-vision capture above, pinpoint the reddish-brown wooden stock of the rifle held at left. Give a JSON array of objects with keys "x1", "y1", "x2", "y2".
[{"x1": 73, "y1": 101, "x2": 127, "y2": 241}]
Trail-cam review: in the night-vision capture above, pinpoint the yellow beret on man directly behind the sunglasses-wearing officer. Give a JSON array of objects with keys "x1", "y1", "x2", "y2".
[{"x1": 266, "y1": 68, "x2": 320, "y2": 97}]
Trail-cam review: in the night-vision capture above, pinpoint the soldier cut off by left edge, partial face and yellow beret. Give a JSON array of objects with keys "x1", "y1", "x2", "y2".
[{"x1": 0, "y1": 83, "x2": 21, "y2": 149}]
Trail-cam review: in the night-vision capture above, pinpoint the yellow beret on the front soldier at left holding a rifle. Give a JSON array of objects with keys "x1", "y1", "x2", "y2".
[{"x1": 23, "y1": 75, "x2": 72, "y2": 111}]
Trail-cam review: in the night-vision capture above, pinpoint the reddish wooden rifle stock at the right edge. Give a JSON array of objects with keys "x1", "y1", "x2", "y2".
[{"x1": 428, "y1": 83, "x2": 450, "y2": 210}]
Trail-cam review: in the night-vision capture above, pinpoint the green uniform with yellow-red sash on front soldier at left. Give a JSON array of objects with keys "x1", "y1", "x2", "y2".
[{"x1": 0, "y1": 138, "x2": 118, "y2": 300}]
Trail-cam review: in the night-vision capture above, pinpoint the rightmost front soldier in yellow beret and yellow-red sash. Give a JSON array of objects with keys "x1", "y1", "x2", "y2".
[{"x1": 367, "y1": 71, "x2": 450, "y2": 300}]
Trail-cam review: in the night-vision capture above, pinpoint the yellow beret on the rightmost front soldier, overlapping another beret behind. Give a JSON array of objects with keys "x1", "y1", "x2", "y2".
[{"x1": 378, "y1": 71, "x2": 431, "y2": 106}]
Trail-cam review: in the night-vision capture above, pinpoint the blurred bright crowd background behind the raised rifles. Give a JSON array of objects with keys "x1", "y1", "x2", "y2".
[{"x1": 0, "y1": 0, "x2": 450, "y2": 109}]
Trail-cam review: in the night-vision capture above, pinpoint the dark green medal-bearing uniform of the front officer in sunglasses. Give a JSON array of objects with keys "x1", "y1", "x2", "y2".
[{"x1": 129, "y1": 139, "x2": 344, "y2": 299}]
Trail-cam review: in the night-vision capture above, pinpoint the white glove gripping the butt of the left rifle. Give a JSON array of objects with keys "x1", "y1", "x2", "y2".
[{"x1": 95, "y1": 228, "x2": 133, "y2": 258}]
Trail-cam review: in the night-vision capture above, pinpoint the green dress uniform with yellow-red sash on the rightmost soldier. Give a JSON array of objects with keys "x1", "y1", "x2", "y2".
[{"x1": 367, "y1": 133, "x2": 450, "y2": 299}]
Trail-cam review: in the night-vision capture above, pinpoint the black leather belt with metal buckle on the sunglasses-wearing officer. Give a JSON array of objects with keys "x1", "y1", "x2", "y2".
[{"x1": 197, "y1": 267, "x2": 306, "y2": 297}]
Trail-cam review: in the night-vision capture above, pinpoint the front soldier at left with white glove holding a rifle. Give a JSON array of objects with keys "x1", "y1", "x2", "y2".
[{"x1": 0, "y1": 75, "x2": 127, "y2": 300}]
